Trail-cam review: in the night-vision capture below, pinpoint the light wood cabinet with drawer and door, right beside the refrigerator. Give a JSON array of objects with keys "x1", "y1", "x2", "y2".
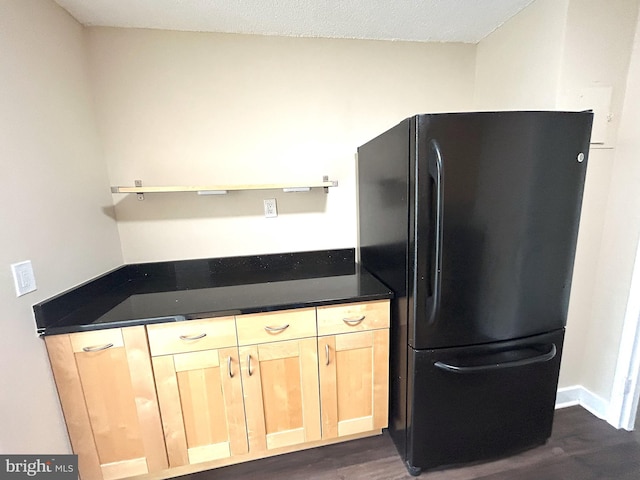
[{"x1": 318, "y1": 301, "x2": 389, "y2": 439}]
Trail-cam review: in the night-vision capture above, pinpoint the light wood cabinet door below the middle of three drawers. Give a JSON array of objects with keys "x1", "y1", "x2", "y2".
[{"x1": 240, "y1": 337, "x2": 321, "y2": 452}]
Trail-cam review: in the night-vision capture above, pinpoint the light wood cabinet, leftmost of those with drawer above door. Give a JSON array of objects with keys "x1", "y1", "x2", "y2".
[{"x1": 147, "y1": 317, "x2": 248, "y2": 468}]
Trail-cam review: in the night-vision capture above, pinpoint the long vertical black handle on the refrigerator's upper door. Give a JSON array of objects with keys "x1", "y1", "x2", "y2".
[{"x1": 427, "y1": 139, "x2": 444, "y2": 324}]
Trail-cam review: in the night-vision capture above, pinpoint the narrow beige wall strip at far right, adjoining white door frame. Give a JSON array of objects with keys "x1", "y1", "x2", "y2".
[{"x1": 580, "y1": 5, "x2": 640, "y2": 399}]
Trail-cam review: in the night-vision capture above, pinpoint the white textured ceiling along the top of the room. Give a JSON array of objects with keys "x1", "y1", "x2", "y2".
[{"x1": 56, "y1": 0, "x2": 533, "y2": 43}]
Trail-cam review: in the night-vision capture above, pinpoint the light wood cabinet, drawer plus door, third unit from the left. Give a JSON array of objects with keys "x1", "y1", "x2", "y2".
[{"x1": 236, "y1": 308, "x2": 321, "y2": 453}]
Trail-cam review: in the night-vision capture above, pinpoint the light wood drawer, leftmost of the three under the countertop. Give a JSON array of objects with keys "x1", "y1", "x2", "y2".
[{"x1": 147, "y1": 317, "x2": 237, "y2": 357}]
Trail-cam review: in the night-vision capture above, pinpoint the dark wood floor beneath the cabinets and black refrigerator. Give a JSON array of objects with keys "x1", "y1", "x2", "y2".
[{"x1": 182, "y1": 407, "x2": 640, "y2": 480}]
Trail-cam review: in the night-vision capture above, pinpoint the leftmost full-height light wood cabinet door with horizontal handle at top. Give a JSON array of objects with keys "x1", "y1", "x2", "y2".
[{"x1": 45, "y1": 326, "x2": 167, "y2": 480}]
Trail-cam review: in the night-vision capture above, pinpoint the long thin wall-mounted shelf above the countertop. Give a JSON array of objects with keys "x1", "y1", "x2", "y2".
[{"x1": 111, "y1": 176, "x2": 338, "y2": 200}]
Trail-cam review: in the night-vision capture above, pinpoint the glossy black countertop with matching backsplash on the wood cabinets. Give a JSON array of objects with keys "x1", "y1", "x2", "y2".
[{"x1": 33, "y1": 249, "x2": 393, "y2": 335}]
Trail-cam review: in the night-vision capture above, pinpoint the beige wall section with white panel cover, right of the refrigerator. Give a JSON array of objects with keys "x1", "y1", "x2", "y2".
[{"x1": 558, "y1": 0, "x2": 640, "y2": 401}]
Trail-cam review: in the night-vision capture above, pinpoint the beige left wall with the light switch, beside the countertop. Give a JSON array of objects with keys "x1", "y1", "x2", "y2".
[{"x1": 0, "y1": 0, "x2": 122, "y2": 453}]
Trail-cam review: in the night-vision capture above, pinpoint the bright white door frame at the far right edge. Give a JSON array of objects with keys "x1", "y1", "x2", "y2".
[{"x1": 607, "y1": 238, "x2": 640, "y2": 430}]
